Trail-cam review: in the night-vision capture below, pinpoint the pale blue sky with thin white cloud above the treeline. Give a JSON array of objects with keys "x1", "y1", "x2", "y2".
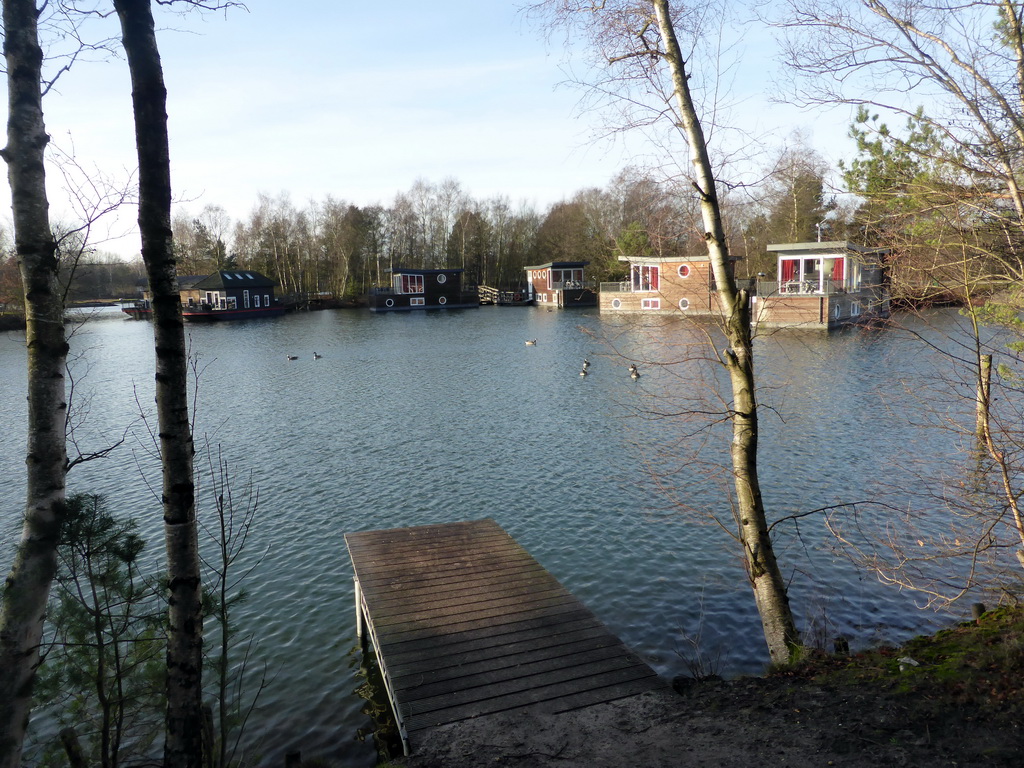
[{"x1": 0, "y1": 0, "x2": 851, "y2": 258}]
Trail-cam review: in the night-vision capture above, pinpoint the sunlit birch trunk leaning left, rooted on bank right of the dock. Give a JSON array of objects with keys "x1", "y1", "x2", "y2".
[{"x1": 652, "y1": 0, "x2": 800, "y2": 664}]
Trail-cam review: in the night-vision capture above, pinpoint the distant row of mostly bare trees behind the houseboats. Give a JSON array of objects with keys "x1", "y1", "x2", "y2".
[{"x1": 6, "y1": 126, "x2": 966, "y2": 311}]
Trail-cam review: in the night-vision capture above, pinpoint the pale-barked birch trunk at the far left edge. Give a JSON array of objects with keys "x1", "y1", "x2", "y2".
[{"x1": 0, "y1": 0, "x2": 68, "y2": 768}]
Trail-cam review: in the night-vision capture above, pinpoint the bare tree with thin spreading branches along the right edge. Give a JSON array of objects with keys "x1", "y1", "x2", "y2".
[{"x1": 776, "y1": 0, "x2": 1024, "y2": 602}]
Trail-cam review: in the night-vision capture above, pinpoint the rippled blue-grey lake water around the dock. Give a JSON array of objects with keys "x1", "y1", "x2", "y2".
[{"x1": 0, "y1": 307, "x2": 983, "y2": 765}]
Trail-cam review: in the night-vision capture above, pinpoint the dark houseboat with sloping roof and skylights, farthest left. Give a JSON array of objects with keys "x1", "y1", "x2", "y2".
[{"x1": 181, "y1": 269, "x2": 285, "y2": 323}]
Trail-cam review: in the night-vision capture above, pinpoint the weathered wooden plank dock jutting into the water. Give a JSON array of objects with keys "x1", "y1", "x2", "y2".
[{"x1": 345, "y1": 519, "x2": 665, "y2": 754}]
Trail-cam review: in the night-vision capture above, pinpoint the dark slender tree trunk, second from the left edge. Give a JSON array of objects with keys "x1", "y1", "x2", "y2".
[{"x1": 114, "y1": 0, "x2": 203, "y2": 768}]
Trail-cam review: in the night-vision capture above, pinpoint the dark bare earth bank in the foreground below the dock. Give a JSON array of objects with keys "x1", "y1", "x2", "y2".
[{"x1": 408, "y1": 677, "x2": 1024, "y2": 768}]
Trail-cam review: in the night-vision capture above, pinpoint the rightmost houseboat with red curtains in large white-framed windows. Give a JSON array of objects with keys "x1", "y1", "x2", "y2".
[{"x1": 751, "y1": 241, "x2": 889, "y2": 330}]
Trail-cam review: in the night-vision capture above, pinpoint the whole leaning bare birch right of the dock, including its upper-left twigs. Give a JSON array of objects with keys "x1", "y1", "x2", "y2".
[{"x1": 534, "y1": 0, "x2": 800, "y2": 663}]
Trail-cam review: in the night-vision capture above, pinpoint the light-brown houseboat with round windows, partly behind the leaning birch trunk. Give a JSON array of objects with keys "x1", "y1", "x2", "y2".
[{"x1": 599, "y1": 256, "x2": 718, "y2": 314}]
